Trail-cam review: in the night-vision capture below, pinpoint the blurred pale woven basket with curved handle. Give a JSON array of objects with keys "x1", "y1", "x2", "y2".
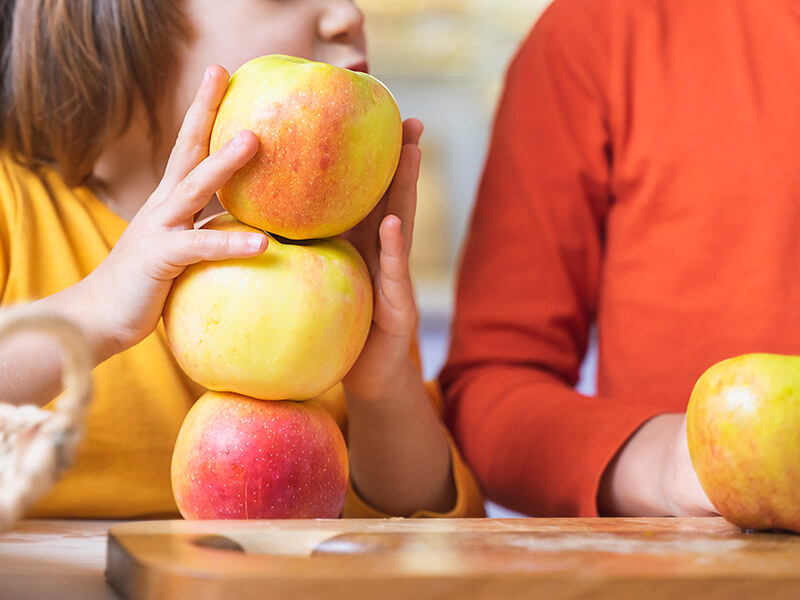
[{"x1": 0, "y1": 307, "x2": 92, "y2": 531}]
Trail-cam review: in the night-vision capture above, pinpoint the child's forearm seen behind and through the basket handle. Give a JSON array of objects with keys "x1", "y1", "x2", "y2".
[{"x1": 0, "y1": 281, "x2": 109, "y2": 406}]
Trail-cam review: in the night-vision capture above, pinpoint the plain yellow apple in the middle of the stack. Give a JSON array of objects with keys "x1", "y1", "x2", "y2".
[{"x1": 163, "y1": 215, "x2": 372, "y2": 400}]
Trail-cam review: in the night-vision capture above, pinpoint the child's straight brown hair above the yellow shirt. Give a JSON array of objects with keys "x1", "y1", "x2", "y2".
[{"x1": 0, "y1": 0, "x2": 188, "y2": 185}]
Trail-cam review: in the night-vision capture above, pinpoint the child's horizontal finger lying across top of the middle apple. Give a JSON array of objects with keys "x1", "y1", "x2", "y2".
[{"x1": 161, "y1": 229, "x2": 268, "y2": 267}]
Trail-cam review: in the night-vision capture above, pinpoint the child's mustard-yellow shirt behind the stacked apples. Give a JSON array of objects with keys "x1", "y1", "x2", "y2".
[{"x1": 0, "y1": 151, "x2": 483, "y2": 518}]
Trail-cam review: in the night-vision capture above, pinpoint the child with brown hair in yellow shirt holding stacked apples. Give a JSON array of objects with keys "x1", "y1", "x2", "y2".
[{"x1": 0, "y1": 0, "x2": 482, "y2": 518}]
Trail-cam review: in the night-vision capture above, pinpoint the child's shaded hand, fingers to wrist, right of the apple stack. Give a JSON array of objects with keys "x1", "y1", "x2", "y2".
[{"x1": 343, "y1": 119, "x2": 422, "y2": 402}]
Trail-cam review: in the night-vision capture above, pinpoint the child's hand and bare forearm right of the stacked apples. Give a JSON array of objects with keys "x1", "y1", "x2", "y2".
[{"x1": 342, "y1": 119, "x2": 456, "y2": 515}]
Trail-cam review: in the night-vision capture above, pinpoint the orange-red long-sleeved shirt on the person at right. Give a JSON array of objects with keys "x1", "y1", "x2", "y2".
[{"x1": 440, "y1": 0, "x2": 800, "y2": 516}]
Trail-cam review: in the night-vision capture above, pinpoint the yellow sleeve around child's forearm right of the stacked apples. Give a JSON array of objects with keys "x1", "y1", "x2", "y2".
[{"x1": 342, "y1": 381, "x2": 486, "y2": 519}]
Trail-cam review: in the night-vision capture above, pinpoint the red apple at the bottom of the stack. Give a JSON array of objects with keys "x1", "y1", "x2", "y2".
[{"x1": 172, "y1": 392, "x2": 349, "y2": 519}]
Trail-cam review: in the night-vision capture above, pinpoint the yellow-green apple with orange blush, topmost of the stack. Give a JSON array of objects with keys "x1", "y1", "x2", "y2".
[{"x1": 210, "y1": 55, "x2": 403, "y2": 239}]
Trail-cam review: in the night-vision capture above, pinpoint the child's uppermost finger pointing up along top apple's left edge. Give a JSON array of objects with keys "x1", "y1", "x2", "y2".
[{"x1": 163, "y1": 65, "x2": 228, "y2": 189}]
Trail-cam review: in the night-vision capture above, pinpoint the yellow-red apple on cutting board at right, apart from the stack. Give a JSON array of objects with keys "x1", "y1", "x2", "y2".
[{"x1": 686, "y1": 354, "x2": 800, "y2": 532}]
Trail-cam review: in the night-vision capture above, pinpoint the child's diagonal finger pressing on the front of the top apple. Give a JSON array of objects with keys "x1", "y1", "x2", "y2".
[{"x1": 159, "y1": 130, "x2": 258, "y2": 225}]
